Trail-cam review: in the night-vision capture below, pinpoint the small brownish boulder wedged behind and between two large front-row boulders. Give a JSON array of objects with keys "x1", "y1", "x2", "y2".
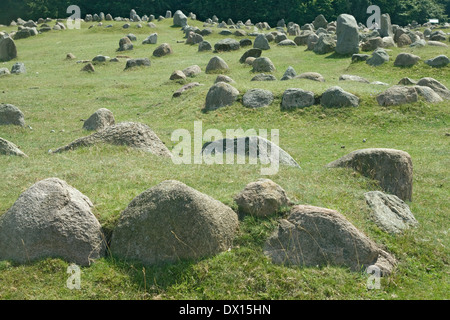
[{"x1": 234, "y1": 179, "x2": 291, "y2": 217}]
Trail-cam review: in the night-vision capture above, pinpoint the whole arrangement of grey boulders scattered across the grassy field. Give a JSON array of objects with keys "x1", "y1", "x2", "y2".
[{"x1": 0, "y1": 10, "x2": 450, "y2": 274}]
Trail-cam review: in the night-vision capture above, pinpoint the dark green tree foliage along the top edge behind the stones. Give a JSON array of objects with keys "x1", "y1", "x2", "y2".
[{"x1": 0, "y1": 0, "x2": 450, "y2": 25}]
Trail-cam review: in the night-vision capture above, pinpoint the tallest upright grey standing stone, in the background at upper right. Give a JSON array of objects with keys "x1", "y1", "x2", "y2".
[{"x1": 336, "y1": 14, "x2": 359, "y2": 55}]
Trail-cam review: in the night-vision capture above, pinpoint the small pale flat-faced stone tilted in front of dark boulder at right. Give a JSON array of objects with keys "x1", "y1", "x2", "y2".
[{"x1": 364, "y1": 191, "x2": 418, "y2": 234}]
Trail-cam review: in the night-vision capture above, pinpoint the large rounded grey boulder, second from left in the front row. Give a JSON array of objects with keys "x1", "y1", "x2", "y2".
[{"x1": 111, "y1": 180, "x2": 238, "y2": 265}]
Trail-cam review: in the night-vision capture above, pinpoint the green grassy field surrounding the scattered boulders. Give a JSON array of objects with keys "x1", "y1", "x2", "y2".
[{"x1": 0, "y1": 20, "x2": 450, "y2": 299}]
